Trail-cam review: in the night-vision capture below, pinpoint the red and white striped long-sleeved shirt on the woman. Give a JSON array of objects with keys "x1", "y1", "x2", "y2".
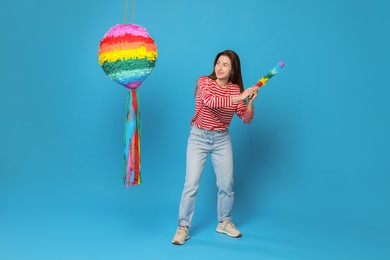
[{"x1": 191, "y1": 76, "x2": 254, "y2": 130}]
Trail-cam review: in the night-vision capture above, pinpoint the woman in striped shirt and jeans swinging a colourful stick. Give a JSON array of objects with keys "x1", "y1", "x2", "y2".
[{"x1": 172, "y1": 50, "x2": 259, "y2": 245}]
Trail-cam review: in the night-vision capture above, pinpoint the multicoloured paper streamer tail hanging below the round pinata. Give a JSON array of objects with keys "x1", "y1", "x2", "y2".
[{"x1": 123, "y1": 89, "x2": 141, "y2": 188}]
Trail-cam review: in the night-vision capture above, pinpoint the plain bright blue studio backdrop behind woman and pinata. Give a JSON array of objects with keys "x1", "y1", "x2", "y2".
[{"x1": 0, "y1": 0, "x2": 390, "y2": 260}]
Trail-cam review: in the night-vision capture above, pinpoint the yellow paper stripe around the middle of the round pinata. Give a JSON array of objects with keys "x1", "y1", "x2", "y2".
[{"x1": 99, "y1": 46, "x2": 157, "y2": 65}]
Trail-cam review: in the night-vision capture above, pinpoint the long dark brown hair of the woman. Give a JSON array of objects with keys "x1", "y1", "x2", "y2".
[{"x1": 195, "y1": 50, "x2": 244, "y2": 95}]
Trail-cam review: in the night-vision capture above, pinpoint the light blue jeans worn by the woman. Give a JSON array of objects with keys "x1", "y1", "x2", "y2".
[{"x1": 179, "y1": 126, "x2": 234, "y2": 226}]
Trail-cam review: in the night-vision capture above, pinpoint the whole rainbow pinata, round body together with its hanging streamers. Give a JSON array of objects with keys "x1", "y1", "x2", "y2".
[{"x1": 98, "y1": 24, "x2": 157, "y2": 187}]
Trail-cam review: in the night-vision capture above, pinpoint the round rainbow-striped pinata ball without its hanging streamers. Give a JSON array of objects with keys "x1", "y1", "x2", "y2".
[{"x1": 98, "y1": 24, "x2": 157, "y2": 89}]
